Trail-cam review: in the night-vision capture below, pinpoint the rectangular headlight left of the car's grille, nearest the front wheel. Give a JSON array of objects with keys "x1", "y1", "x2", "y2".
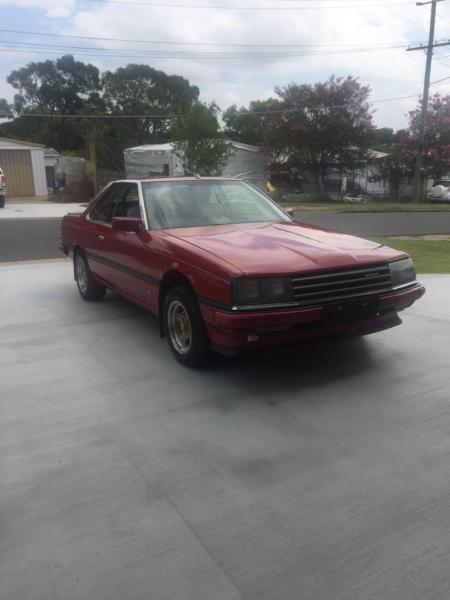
[{"x1": 234, "y1": 277, "x2": 293, "y2": 306}]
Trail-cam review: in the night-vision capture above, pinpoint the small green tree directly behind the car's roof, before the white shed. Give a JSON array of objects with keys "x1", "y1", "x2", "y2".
[{"x1": 170, "y1": 102, "x2": 231, "y2": 176}]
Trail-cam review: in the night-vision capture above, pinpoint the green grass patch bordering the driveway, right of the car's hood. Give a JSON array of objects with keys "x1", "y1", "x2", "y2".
[{"x1": 371, "y1": 238, "x2": 450, "y2": 273}]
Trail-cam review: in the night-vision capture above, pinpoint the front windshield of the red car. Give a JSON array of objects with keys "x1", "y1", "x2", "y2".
[{"x1": 142, "y1": 181, "x2": 290, "y2": 229}]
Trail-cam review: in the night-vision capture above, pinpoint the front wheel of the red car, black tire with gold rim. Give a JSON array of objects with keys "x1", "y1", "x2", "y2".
[{"x1": 162, "y1": 286, "x2": 211, "y2": 367}]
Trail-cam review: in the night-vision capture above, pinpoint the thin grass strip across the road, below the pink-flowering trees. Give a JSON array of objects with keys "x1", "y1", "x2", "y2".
[{"x1": 277, "y1": 197, "x2": 450, "y2": 212}]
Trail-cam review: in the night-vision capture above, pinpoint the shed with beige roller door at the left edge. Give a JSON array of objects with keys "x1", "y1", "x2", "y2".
[{"x1": 0, "y1": 138, "x2": 47, "y2": 196}]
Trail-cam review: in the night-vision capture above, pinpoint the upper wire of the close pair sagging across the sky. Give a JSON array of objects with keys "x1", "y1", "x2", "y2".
[{"x1": 0, "y1": 28, "x2": 412, "y2": 48}]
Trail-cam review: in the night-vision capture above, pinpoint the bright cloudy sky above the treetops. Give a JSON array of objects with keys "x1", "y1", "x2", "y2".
[{"x1": 0, "y1": 0, "x2": 450, "y2": 129}]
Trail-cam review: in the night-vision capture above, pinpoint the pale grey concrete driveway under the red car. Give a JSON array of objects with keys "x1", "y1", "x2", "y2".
[{"x1": 0, "y1": 263, "x2": 450, "y2": 600}]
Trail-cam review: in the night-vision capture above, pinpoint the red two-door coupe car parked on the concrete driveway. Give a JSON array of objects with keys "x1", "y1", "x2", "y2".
[{"x1": 61, "y1": 178, "x2": 425, "y2": 366}]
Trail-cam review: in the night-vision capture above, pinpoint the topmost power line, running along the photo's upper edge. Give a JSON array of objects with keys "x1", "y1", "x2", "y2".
[{"x1": 84, "y1": 0, "x2": 414, "y2": 11}]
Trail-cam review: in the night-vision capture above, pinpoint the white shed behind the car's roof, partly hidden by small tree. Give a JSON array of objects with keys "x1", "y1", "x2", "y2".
[{"x1": 124, "y1": 142, "x2": 267, "y2": 183}]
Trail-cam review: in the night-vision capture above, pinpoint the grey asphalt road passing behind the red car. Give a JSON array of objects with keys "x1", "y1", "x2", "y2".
[{"x1": 0, "y1": 211, "x2": 450, "y2": 262}]
